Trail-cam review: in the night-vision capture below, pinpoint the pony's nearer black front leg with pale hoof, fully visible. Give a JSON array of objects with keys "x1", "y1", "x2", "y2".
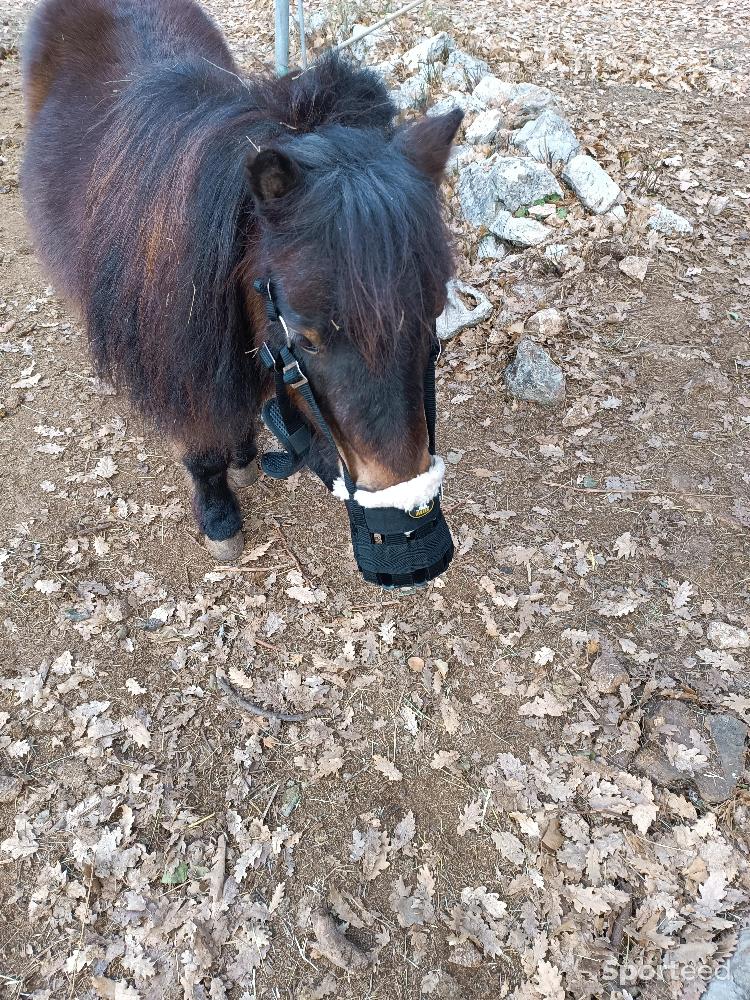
[{"x1": 182, "y1": 451, "x2": 244, "y2": 562}]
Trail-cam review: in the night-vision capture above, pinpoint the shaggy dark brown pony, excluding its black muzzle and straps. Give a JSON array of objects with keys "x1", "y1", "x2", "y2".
[{"x1": 22, "y1": 0, "x2": 461, "y2": 558}]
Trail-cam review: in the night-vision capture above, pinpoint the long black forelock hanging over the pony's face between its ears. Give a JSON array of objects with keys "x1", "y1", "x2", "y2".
[{"x1": 269, "y1": 125, "x2": 452, "y2": 369}]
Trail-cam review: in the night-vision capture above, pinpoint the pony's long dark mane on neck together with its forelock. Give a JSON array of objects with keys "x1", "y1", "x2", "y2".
[{"x1": 81, "y1": 57, "x2": 449, "y2": 438}]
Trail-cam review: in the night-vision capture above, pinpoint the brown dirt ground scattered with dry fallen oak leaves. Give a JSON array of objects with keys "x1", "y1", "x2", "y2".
[{"x1": 0, "y1": 0, "x2": 750, "y2": 1000}]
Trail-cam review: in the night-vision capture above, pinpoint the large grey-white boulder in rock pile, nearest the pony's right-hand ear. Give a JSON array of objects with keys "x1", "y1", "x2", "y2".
[{"x1": 458, "y1": 154, "x2": 563, "y2": 229}]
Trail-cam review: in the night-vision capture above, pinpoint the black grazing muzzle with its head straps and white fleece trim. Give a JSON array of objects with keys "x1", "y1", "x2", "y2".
[{"x1": 255, "y1": 281, "x2": 454, "y2": 588}]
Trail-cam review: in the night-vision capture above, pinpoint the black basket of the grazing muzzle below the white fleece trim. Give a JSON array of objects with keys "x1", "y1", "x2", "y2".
[{"x1": 346, "y1": 496, "x2": 454, "y2": 589}]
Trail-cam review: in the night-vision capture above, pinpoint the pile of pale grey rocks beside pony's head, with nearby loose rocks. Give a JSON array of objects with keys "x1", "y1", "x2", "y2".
[{"x1": 360, "y1": 32, "x2": 692, "y2": 403}]
